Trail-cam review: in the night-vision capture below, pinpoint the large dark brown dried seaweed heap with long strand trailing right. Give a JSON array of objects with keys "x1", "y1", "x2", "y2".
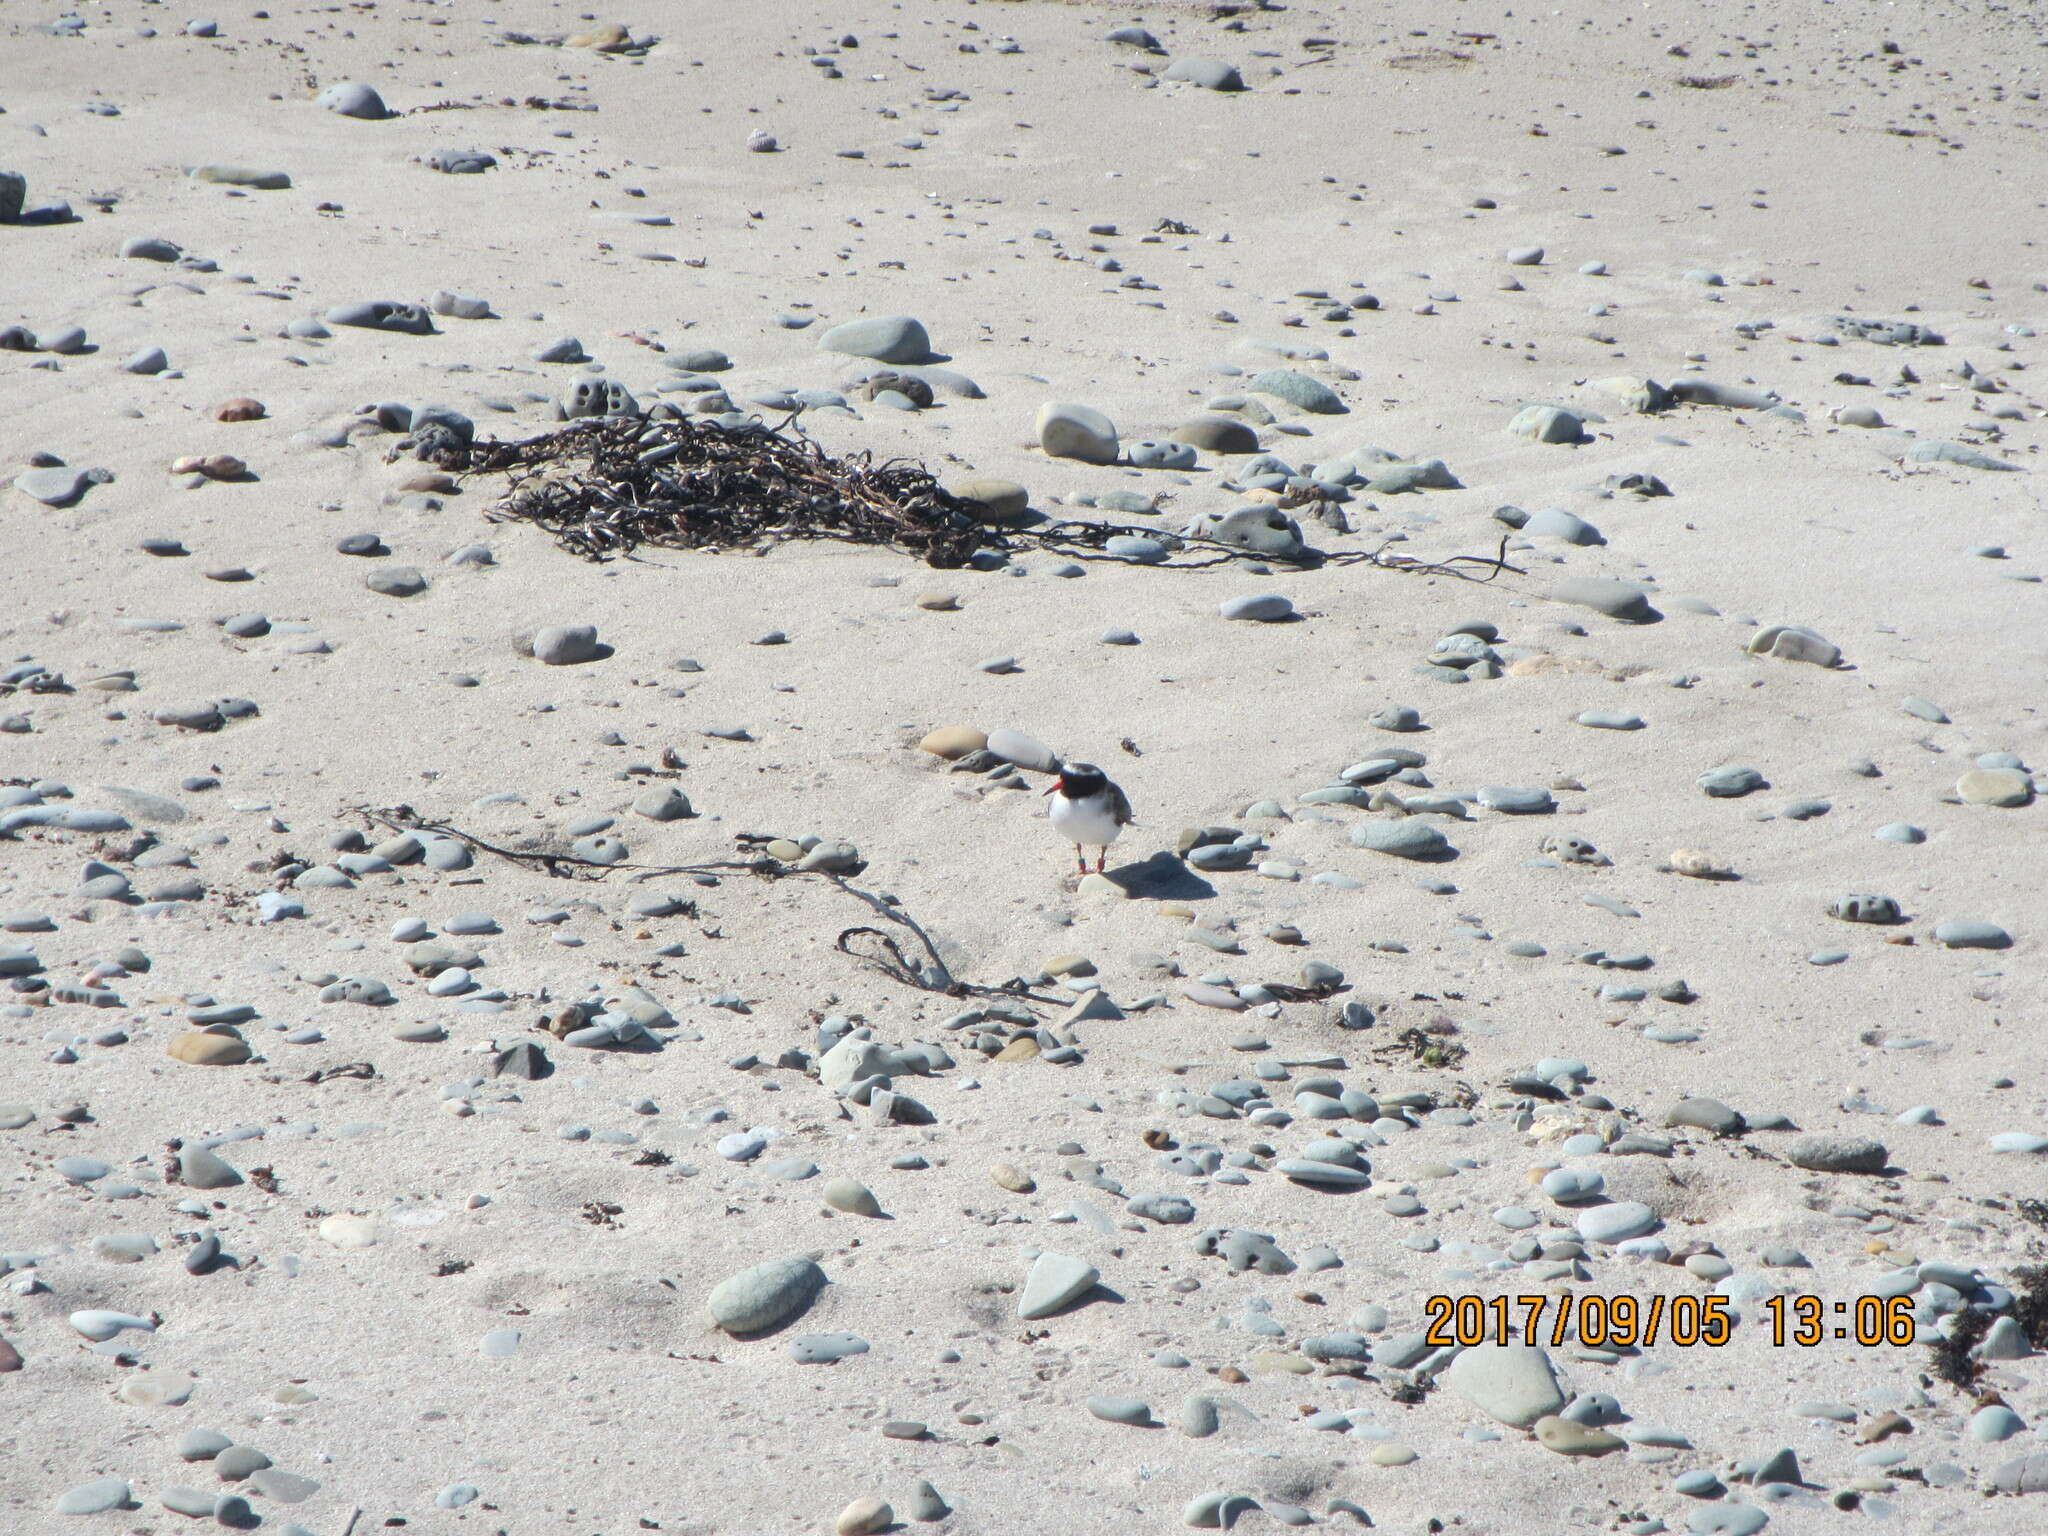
[{"x1": 432, "y1": 416, "x2": 1516, "y2": 580}]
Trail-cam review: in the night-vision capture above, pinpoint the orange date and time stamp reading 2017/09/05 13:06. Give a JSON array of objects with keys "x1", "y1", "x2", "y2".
[{"x1": 1423, "y1": 1294, "x2": 1919, "y2": 1350}]
